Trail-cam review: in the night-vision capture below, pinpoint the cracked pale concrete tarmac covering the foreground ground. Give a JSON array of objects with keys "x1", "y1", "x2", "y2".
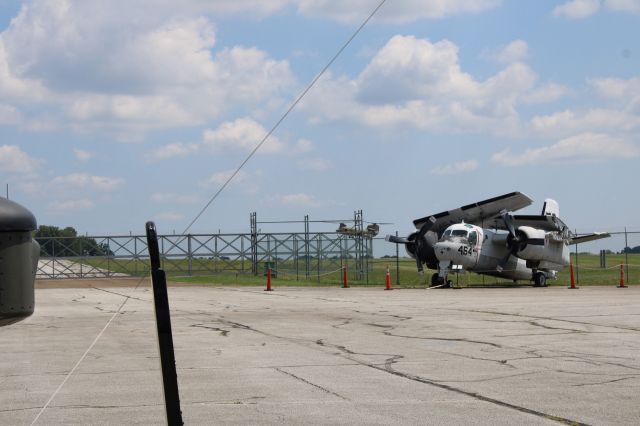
[{"x1": 0, "y1": 280, "x2": 640, "y2": 425}]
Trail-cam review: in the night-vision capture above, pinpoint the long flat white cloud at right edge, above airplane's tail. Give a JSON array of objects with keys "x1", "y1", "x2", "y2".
[{"x1": 491, "y1": 133, "x2": 640, "y2": 167}]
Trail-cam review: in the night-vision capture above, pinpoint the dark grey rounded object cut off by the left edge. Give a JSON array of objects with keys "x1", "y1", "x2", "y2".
[{"x1": 0, "y1": 197, "x2": 40, "y2": 327}]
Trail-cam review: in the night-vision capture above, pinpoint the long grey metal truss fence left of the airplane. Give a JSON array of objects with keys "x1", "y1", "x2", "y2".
[{"x1": 36, "y1": 232, "x2": 373, "y2": 280}]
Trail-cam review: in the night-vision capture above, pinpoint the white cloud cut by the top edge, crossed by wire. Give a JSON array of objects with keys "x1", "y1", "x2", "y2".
[{"x1": 296, "y1": 0, "x2": 501, "y2": 23}]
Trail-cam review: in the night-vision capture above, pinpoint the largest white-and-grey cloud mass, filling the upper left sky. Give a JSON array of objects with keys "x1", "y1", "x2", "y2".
[{"x1": 0, "y1": 0, "x2": 295, "y2": 136}]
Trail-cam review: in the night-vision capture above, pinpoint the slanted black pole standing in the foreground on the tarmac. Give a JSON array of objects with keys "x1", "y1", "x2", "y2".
[{"x1": 146, "y1": 222, "x2": 184, "y2": 426}]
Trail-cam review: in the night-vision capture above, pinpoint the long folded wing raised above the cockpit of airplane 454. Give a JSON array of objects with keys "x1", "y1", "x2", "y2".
[{"x1": 413, "y1": 192, "x2": 533, "y2": 234}]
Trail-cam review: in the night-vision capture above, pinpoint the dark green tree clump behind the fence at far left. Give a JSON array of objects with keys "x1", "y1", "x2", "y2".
[{"x1": 33, "y1": 225, "x2": 113, "y2": 257}]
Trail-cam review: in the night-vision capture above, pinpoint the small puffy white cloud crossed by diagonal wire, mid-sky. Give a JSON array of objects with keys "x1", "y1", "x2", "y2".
[{"x1": 203, "y1": 118, "x2": 283, "y2": 153}]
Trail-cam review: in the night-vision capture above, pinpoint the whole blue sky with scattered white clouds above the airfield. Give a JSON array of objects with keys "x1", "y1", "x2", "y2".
[{"x1": 0, "y1": 0, "x2": 640, "y2": 251}]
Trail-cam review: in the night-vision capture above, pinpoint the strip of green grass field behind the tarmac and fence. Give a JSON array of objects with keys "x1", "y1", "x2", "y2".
[{"x1": 66, "y1": 254, "x2": 640, "y2": 287}]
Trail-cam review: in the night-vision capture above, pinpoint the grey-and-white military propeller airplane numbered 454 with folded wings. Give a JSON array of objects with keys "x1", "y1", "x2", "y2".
[{"x1": 385, "y1": 192, "x2": 610, "y2": 287}]
